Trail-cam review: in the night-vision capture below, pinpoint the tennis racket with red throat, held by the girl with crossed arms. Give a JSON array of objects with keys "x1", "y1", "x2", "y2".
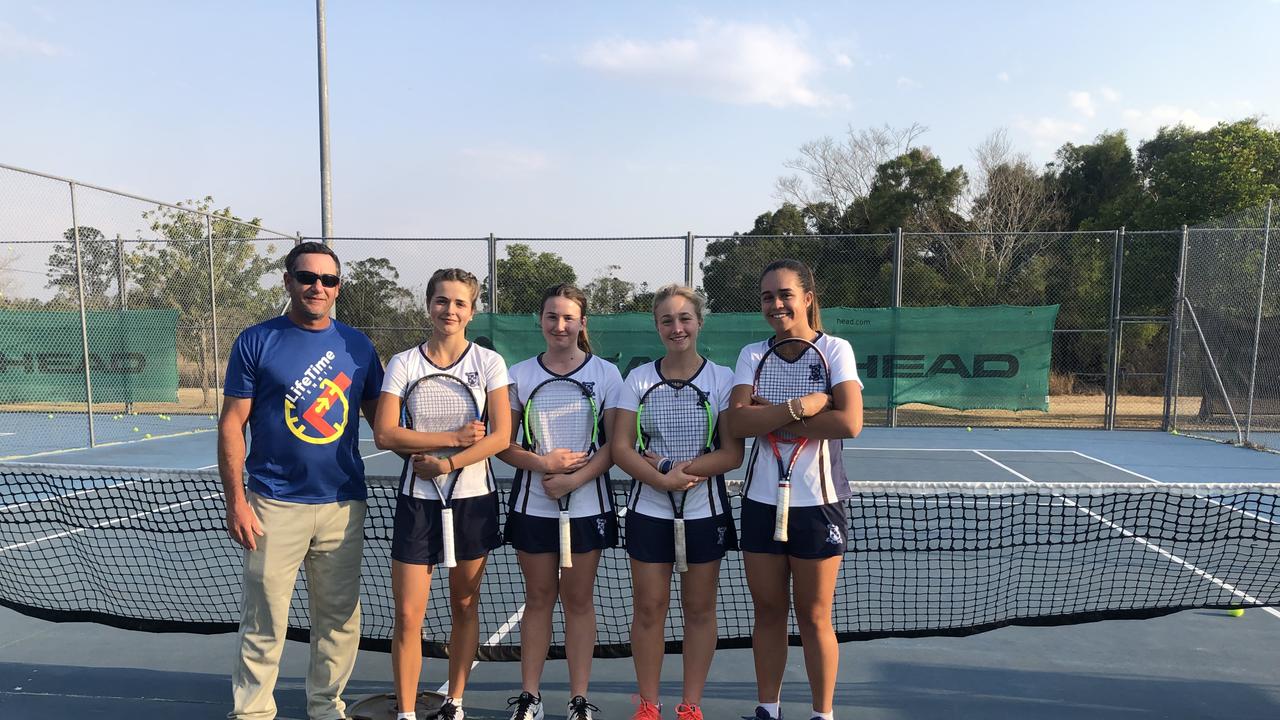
[{"x1": 753, "y1": 337, "x2": 831, "y2": 542}]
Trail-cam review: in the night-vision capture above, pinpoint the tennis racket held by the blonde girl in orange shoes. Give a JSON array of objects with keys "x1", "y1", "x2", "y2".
[{"x1": 636, "y1": 380, "x2": 716, "y2": 573}]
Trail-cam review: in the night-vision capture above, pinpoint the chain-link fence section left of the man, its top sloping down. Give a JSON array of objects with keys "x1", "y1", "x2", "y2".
[{"x1": 0, "y1": 165, "x2": 297, "y2": 457}]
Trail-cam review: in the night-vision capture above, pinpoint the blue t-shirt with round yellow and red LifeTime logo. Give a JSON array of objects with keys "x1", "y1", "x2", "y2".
[{"x1": 224, "y1": 315, "x2": 383, "y2": 503}]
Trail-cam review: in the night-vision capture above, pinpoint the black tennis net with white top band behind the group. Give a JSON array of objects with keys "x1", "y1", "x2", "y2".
[{"x1": 0, "y1": 465, "x2": 1280, "y2": 660}]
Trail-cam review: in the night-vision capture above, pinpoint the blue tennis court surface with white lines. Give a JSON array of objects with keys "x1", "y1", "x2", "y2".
[{"x1": 0, "y1": 425, "x2": 1280, "y2": 720}]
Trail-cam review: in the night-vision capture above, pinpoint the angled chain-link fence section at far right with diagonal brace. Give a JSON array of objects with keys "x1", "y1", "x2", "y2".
[{"x1": 1170, "y1": 201, "x2": 1280, "y2": 451}]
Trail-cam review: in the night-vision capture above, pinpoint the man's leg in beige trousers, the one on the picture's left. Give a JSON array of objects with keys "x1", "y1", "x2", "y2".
[{"x1": 228, "y1": 492, "x2": 314, "y2": 720}]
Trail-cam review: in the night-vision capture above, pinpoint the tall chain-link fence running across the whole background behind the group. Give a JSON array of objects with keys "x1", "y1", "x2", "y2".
[{"x1": 0, "y1": 165, "x2": 1280, "y2": 456}]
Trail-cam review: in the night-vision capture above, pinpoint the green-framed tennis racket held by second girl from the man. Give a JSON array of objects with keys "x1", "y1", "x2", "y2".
[{"x1": 524, "y1": 378, "x2": 599, "y2": 568}]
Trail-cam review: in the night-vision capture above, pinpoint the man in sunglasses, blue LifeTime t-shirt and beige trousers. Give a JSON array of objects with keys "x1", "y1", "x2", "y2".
[{"x1": 218, "y1": 242, "x2": 383, "y2": 720}]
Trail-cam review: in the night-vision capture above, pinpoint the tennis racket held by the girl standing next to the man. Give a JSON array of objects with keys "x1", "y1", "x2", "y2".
[{"x1": 401, "y1": 373, "x2": 480, "y2": 568}]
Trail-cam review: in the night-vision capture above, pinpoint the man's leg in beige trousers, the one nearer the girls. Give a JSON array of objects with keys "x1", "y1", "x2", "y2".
[{"x1": 306, "y1": 501, "x2": 366, "y2": 720}]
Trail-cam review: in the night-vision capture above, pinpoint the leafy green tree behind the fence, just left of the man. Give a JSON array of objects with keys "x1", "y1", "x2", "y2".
[{"x1": 128, "y1": 197, "x2": 283, "y2": 405}]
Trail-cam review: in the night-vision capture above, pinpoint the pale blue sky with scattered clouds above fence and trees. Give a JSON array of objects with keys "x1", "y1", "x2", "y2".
[{"x1": 0, "y1": 0, "x2": 1280, "y2": 237}]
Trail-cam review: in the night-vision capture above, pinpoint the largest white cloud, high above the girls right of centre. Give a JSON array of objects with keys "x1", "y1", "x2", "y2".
[{"x1": 579, "y1": 22, "x2": 845, "y2": 108}]
